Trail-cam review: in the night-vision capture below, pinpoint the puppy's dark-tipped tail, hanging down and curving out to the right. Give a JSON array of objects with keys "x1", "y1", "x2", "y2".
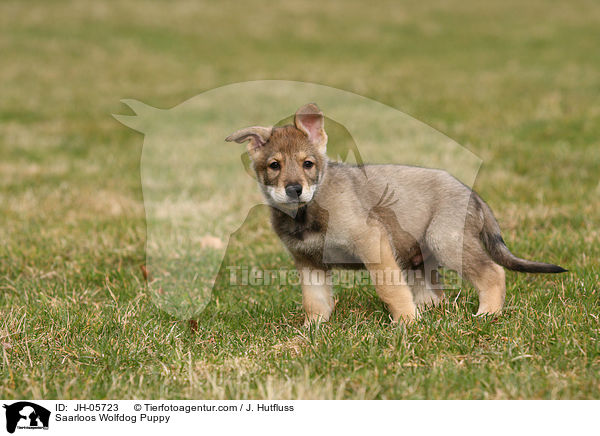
[{"x1": 474, "y1": 194, "x2": 567, "y2": 273}]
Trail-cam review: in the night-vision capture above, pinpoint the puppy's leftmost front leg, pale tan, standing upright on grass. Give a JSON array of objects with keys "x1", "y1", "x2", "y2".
[{"x1": 298, "y1": 264, "x2": 335, "y2": 326}]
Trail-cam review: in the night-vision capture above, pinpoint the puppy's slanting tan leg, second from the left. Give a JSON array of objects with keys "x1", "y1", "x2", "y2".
[{"x1": 356, "y1": 229, "x2": 417, "y2": 323}]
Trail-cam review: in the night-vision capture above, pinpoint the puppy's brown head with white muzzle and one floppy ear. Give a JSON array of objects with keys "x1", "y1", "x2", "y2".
[{"x1": 225, "y1": 103, "x2": 327, "y2": 209}]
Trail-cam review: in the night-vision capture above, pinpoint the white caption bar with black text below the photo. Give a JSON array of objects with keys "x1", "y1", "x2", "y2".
[{"x1": 0, "y1": 400, "x2": 598, "y2": 436}]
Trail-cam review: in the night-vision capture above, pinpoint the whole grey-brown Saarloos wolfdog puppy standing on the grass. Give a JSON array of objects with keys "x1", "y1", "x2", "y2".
[{"x1": 226, "y1": 104, "x2": 566, "y2": 324}]
